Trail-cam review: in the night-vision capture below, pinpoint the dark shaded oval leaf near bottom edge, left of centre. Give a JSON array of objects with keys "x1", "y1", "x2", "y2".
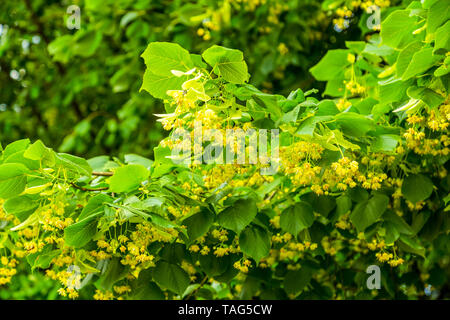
[{"x1": 153, "y1": 261, "x2": 191, "y2": 295}]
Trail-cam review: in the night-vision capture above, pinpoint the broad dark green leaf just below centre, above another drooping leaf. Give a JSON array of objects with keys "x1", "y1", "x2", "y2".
[{"x1": 217, "y1": 199, "x2": 257, "y2": 234}]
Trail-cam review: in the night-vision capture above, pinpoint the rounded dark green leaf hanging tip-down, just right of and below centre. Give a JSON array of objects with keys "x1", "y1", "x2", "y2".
[{"x1": 280, "y1": 201, "x2": 314, "y2": 236}]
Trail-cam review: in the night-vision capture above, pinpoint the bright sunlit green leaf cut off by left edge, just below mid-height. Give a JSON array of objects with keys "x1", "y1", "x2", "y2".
[{"x1": 0, "y1": 163, "x2": 28, "y2": 199}]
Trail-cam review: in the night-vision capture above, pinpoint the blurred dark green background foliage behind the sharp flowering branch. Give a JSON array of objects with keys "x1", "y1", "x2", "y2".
[{"x1": 0, "y1": 0, "x2": 359, "y2": 156}]
